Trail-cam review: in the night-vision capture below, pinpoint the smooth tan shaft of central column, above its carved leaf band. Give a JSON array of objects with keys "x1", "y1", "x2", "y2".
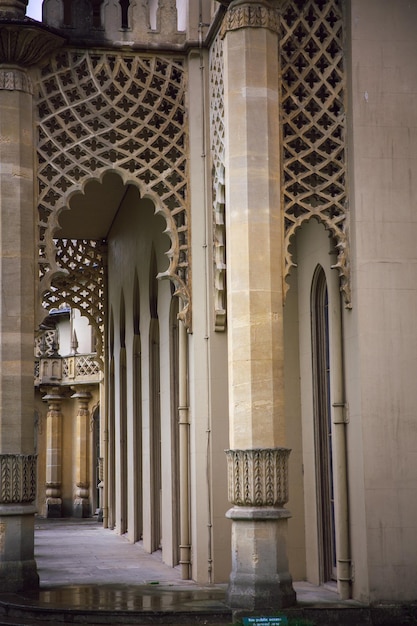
[{"x1": 224, "y1": 15, "x2": 285, "y2": 448}]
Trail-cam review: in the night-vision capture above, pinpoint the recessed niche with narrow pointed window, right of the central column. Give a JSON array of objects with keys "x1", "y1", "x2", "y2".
[{"x1": 284, "y1": 218, "x2": 350, "y2": 598}]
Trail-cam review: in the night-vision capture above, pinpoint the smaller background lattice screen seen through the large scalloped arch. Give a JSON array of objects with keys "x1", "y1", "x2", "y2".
[{"x1": 42, "y1": 239, "x2": 106, "y2": 366}]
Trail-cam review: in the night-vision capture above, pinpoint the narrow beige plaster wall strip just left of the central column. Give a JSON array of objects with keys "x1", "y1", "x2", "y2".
[{"x1": 188, "y1": 50, "x2": 231, "y2": 583}]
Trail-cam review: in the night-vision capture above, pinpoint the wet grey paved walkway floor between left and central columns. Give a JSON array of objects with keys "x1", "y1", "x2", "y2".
[{"x1": 35, "y1": 519, "x2": 226, "y2": 611}]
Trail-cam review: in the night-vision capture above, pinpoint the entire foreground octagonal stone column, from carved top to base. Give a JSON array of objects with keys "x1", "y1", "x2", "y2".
[{"x1": 222, "y1": 0, "x2": 295, "y2": 613}]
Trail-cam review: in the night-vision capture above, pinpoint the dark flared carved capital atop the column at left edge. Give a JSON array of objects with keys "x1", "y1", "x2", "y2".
[{"x1": 0, "y1": 20, "x2": 65, "y2": 67}]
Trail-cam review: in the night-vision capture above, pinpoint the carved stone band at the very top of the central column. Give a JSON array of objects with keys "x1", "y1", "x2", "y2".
[{"x1": 221, "y1": 0, "x2": 279, "y2": 37}]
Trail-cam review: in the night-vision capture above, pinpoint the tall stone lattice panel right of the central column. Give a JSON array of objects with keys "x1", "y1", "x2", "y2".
[{"x1": 280, "y1": 0, "x2": 351, "y2": 307}]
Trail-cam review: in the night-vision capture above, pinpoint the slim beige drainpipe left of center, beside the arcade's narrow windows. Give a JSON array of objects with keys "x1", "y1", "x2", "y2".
[{"x1": 178, "y1": 321, "x2": 191, "y2": 580}]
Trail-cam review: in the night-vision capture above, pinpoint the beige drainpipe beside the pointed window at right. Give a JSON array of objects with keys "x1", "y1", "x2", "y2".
[{"x1": 332, "y1": 294, "x2": 352, "y2": 600}]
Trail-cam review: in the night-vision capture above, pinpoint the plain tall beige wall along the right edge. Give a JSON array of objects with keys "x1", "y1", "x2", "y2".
[{"x1": 345, "y1": 0, "x2": 417, "y2": 600}]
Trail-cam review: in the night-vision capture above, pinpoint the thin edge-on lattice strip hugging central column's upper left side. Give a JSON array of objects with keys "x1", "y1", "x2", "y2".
[{"x1": 210, "y1": 36, "x2": 226, "y2": 330}]
